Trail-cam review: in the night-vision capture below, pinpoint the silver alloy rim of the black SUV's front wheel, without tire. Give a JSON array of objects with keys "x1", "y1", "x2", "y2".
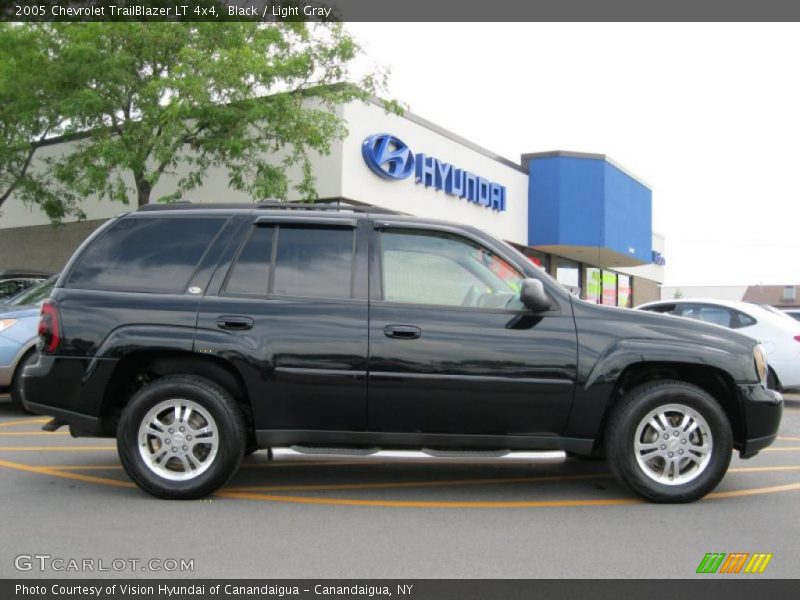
[{"x1": 633, "y1": 404, "x2": 714, "y2": 485}]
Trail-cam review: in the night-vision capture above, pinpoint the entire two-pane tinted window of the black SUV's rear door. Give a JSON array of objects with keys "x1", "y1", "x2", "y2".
[{"x1": 225, "y1": 225, "x2": 355, "y2": 298}]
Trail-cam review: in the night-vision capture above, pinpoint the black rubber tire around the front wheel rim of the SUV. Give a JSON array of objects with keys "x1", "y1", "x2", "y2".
[{"x1": 605, "y1": 381, "x2": 733, "y2": 503}]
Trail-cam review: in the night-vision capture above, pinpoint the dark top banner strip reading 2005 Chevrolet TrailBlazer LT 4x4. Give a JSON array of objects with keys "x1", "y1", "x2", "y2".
[{"x1": 0, "y1": 0, "x2": 800, "y2": 22}]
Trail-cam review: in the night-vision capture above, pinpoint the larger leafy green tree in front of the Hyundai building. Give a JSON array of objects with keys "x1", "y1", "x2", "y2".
[{"x1": 32, "y1": 22, "x2": 394, "y2": 213}]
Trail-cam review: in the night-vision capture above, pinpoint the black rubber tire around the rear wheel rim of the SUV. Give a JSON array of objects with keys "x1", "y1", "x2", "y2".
[{"x1": 117, "y1": 375, "x2": 247, "y2": 500}]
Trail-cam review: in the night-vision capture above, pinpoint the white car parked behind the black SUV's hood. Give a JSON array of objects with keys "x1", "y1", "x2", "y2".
[{"x1": 636, "y1": 298, "x2": 800, "y2": 390}]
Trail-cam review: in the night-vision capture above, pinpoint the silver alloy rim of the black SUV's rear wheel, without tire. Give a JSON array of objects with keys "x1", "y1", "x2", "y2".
[{"x1": 138, "y1": 398, "x2": 219, "y2": 481}]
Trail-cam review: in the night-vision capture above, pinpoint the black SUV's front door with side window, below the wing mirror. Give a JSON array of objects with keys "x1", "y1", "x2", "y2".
[{"x1": 369, "y1": 223, "x2": 577, "y2": 436}]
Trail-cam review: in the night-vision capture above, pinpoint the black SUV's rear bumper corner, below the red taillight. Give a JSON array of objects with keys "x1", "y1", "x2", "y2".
[{"x1": 22, "y1": 355, "x2": 117, "y2": 434}]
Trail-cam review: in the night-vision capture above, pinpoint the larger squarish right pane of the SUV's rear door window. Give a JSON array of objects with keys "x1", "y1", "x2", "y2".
[{"x1": 272, "y1": 226, "x2": 355, "y2": 298}]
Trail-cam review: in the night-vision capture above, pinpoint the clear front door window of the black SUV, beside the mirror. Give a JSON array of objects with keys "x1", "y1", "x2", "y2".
[{"x1": 381, "y1": 230, "x2": 523, "y2": 310}]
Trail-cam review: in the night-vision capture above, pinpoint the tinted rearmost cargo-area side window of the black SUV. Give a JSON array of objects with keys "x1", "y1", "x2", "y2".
[{"x1": 67, "y1": 217, "x2": 225, "y2": 294}]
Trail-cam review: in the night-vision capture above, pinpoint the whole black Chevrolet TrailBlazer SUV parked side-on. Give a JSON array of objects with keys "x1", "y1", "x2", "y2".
[{"x1": 23, "y1": 203, "x2": 783, "y2": 502}]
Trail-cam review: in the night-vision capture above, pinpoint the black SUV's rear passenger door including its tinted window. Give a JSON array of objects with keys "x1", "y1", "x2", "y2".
[{"x1": 195, "y1": 217, "x2": 368, "y2": 431}]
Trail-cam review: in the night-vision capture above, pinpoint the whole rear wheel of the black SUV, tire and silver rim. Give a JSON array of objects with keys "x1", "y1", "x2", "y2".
[{"x1": 117, "y1": 375, "x2": 247, "y2": 500}]
